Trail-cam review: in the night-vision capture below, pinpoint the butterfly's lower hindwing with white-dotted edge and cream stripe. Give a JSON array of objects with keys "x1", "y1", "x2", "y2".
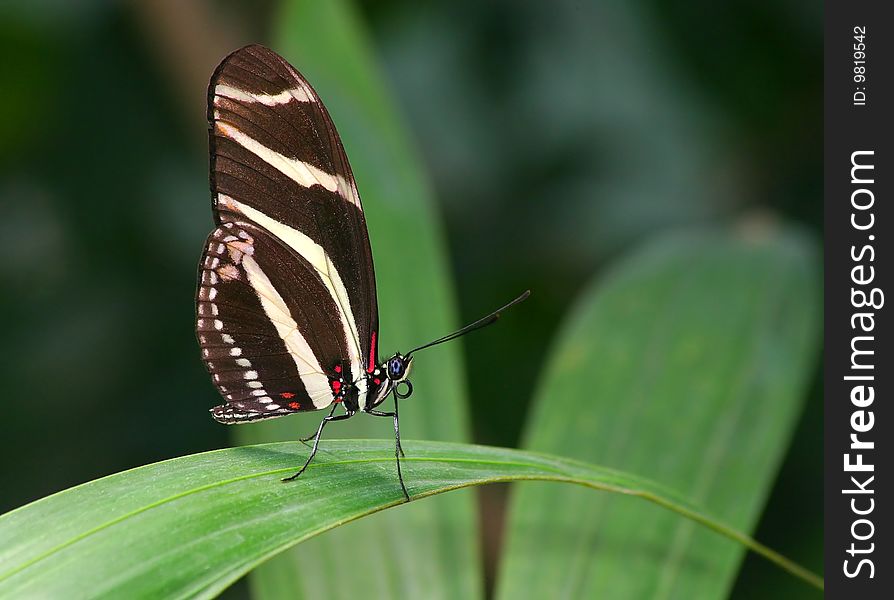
[{"x1": 197, "y1": 223, "x2": 347, "y2": 422}]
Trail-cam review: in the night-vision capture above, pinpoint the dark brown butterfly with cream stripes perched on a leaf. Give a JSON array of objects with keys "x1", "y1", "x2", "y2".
[{"x1": 196, "y1": 45, "x2": 528, "y2": 500}]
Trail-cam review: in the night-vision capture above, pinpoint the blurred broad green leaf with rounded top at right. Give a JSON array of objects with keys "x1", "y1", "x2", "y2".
[{"x1": 497, "y1": 232, "x2": 820, "y2": 599}]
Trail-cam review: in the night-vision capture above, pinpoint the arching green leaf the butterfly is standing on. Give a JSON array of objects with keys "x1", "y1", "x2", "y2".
[{"x1": 0, "y1": 440, "x2": 824, "y2": 598}]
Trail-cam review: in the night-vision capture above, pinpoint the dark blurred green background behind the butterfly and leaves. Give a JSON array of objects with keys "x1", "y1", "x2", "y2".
[{"x1": 0, "y1": 0, "x2": 822, "y2": 596}]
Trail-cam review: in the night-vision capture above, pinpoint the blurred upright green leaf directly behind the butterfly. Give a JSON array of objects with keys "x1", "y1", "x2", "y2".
[{"x1": 237, "y1": 0, "x2": 481, "y2": 599}]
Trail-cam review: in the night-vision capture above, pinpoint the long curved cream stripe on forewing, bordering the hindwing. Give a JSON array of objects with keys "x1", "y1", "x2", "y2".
[{"x1": 226, "y1": 194, "x2": 366, "y2": 406}]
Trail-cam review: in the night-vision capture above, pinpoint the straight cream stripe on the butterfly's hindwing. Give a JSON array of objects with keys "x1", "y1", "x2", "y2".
[{"x1": 242, "y1": 254, "x2": 333, "y2": 408}]
